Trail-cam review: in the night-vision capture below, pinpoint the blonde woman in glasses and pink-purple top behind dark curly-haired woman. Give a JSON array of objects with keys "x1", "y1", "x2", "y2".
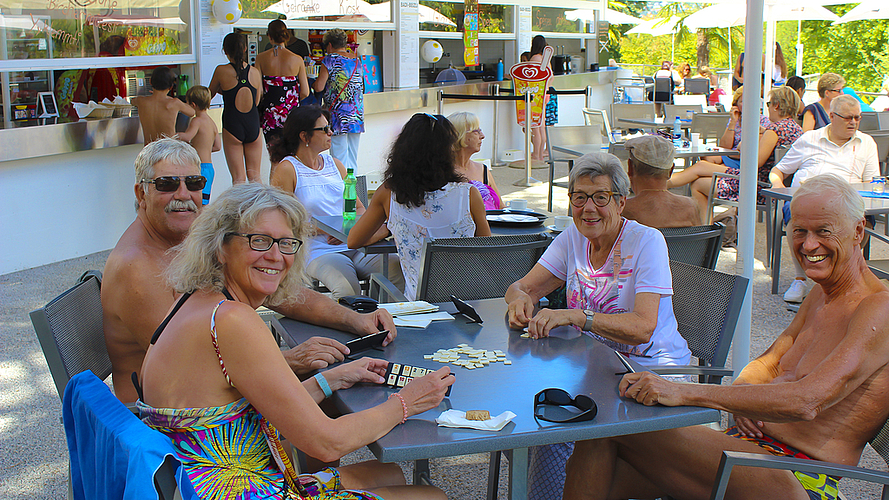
[{"x1": 448, "y1": 111, "x2": 500, "y2": 210}]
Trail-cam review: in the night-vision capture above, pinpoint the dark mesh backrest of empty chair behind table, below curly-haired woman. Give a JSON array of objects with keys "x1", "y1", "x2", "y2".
[{"x1": 417, "y1": 233, "x2": 552, "y2": 302}]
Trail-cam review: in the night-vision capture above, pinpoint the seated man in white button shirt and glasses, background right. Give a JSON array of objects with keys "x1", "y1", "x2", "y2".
[{"x1": 769, "y1": 95, "x2": 880, "y2": 302}]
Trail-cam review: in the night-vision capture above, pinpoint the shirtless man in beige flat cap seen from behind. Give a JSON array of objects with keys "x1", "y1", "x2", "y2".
[{"x1": 623, "y1": 135, "x2": 701, "y2": 227}]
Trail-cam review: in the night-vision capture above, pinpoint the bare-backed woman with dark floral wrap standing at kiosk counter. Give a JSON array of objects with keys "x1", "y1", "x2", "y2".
[{"x1": 256, "y1": 19, "x2": 309, "y2": 147}]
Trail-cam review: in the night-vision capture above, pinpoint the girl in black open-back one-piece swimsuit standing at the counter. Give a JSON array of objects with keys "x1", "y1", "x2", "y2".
[{"x1": 208, "y1": 33, "x2": 262, "y2": 184}]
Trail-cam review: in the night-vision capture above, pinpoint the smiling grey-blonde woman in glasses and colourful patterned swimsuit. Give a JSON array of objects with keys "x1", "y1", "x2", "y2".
[{"x1": 138, "y1": 183, "x2": 454, "y2": 500}]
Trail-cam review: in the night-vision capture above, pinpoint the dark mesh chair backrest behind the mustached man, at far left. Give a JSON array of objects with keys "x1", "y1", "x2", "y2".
[{"x1": 31, "y1": 271, "x2": 111, "y2": 398}]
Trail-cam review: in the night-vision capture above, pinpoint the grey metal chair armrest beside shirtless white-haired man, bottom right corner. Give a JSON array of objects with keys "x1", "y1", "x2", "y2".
[{"x1": 710, "y1": 421, "x2": 889, "y2": 500}]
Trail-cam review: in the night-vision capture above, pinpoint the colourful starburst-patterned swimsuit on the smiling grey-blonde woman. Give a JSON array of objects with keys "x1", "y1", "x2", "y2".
[{"x1": 136, "y1": 291, "x2": 382, "y2": 500}]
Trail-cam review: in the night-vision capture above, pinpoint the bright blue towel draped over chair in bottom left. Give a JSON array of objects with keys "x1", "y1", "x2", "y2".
[{"x1": 62, "y1": 371, "x2": 198, "y2": 500}]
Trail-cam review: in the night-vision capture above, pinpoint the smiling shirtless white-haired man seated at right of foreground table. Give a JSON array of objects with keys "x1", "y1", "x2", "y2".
[{"x1": 563, "y1": 175, "x2": 889, "y2": 500}]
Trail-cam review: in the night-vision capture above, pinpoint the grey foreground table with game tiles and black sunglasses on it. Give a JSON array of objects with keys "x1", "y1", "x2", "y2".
[{"x1": 281, "y1": 298, "x2": 719, "y2": 499}]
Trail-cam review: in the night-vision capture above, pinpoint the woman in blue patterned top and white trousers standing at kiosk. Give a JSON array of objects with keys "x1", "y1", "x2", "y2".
[{"x1": 313, "y1": 28, "x2": 364, "y2": 171}]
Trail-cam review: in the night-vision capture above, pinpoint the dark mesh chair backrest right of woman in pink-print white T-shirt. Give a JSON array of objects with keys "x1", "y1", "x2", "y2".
[{"x1": 670, "y1": 261, "x2": 750, "y2": 384}]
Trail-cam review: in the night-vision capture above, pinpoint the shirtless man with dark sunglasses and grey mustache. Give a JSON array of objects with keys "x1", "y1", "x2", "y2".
[{"x1": 102, "y1": 138, "x2": 395, "y2": 403}]
